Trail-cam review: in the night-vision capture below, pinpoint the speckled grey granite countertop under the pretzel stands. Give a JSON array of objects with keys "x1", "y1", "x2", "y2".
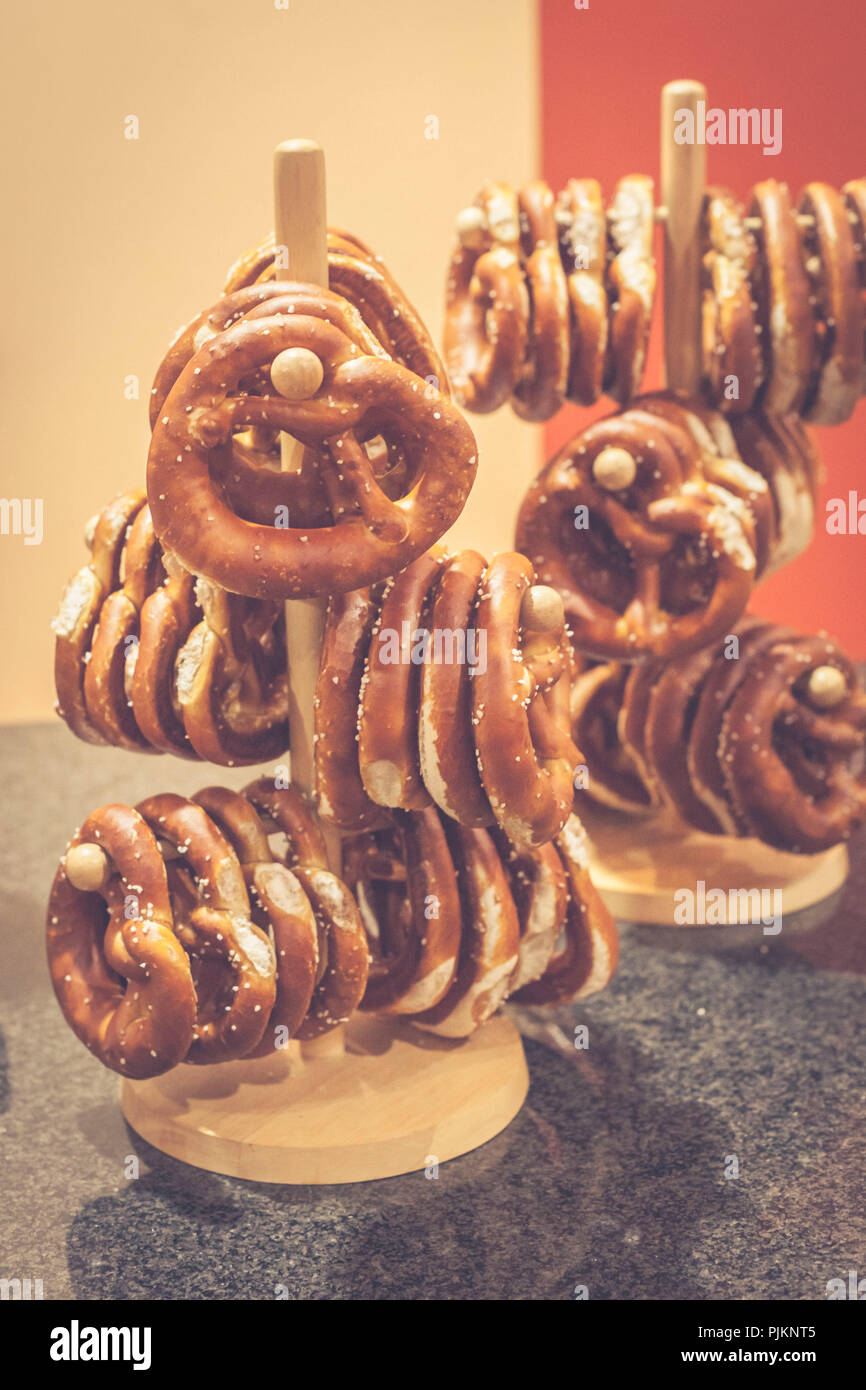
[{"x1": 0, "y1": 724, "x2": 866, "y2": 1300}]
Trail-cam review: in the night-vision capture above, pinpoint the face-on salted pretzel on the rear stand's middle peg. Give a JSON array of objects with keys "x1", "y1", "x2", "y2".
[{"x1": 516, "y1": 407, "x2": 755, "y2": 662}]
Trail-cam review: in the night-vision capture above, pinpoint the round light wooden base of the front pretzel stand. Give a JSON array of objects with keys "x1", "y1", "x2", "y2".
[{"x1": 121, "y1": 1013, "x2": 530, "y2": 1183}]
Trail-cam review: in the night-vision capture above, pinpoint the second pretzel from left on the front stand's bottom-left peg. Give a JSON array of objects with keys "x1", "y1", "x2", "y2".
[{"x1": 136, "y1": 792, "x2": 277, "y2": 1063}]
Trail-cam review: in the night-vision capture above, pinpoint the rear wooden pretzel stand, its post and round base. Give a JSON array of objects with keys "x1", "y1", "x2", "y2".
[{"x1": 577, "y1": 81, "x2": 848, "y2": 942}]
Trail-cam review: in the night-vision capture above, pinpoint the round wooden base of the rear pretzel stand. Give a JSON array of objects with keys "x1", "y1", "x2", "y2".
[{"x1": 580, "y1": 802, "x2": 848, "y2": 941}]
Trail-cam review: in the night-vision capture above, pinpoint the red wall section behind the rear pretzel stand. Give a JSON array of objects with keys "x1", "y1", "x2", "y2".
[{"x1": 541, "y1": 0, "x2": 866, "y2": 657}]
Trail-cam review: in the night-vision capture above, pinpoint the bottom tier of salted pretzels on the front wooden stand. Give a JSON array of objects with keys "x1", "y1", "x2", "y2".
[{"x1": 47, "y1": 778, "x2": 617, "y2": 1080}]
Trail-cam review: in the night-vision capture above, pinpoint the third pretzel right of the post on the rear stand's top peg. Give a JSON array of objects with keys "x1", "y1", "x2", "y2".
[{"x1": 799, "y1": 183, "x2": 866, "y2": 425}]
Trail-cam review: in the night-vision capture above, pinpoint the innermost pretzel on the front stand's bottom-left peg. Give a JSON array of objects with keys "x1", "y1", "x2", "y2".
[{"x1": 243, "y1": 777, "x2": 370, "y2": 1041}]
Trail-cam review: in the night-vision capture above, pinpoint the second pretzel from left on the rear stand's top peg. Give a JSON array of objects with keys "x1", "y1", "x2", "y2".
[{"x1": 512, "y1": 179, "x2": 571, "y2": 420}]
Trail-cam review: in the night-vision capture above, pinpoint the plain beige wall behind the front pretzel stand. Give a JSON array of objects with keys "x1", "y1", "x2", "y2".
[{"x1": 0, "y1": 0, "x2": 541, "y2": 720}]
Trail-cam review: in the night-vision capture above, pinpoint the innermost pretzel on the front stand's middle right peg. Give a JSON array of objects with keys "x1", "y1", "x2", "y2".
[{"x1": 313, "y1": 589, "x2": 384, "y2": 830}]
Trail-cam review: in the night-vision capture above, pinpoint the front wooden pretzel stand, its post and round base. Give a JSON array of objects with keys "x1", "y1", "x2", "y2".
[{"x1": 121, "y1": 140, "x2": 528, "y2": 1183}]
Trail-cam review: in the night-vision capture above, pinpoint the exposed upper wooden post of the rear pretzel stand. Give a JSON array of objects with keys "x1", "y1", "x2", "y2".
[{"x1": 660, "y1": 79, "x2": 706, "y2": 392}]
